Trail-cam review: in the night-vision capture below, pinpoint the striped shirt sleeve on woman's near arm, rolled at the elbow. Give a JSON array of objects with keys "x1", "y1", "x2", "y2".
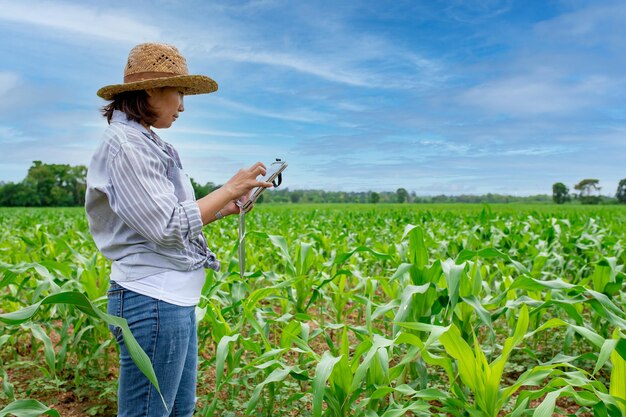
[{"x1": 109, "y1": 143, "x2": 202, "y2": 250}]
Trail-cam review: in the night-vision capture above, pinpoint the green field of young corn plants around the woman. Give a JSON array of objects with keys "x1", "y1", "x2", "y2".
[{"x1": 0, "y1": 205, "x2": 626, "y2": 417}]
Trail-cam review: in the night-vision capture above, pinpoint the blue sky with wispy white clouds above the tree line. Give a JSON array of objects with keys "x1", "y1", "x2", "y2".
[{"x1": 0, "y1": 0, "x2": 626, "y2": 195}]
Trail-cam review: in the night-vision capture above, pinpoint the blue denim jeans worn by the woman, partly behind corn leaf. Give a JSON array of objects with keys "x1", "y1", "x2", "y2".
[{"x1": 107, "y1": 282, "x2": 198, "y2": 417}]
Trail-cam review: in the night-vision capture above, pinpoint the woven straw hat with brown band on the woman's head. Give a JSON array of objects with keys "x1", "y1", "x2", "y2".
[{"x1": 98, "y1": 43, "x2": 217, "y2": 100}]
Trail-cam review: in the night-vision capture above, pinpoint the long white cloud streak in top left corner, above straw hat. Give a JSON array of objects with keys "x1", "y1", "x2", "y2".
[{"x1": 0, "y1": 1, "x2": 161, "y2": 42}]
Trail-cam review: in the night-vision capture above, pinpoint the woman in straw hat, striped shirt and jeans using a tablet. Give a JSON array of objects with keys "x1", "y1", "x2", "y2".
[{"x1": 85, "y1": 43, "x2": 271, "y2": 417}]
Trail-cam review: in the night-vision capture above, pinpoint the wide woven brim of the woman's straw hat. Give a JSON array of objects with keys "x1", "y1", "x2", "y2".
[{"x1": 97, "y1": 75, "x2": 217, "y2": 100}]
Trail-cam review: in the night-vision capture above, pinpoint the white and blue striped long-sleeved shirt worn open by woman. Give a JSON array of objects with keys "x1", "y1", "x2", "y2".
[{"x1": 85, "y1": 110, "x2": 220, "y2": 282}]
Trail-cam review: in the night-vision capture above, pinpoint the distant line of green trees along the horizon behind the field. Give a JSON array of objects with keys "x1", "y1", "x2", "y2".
[{"x1": 0, "y1": 161, "x2": 626, "y2": 207}]
